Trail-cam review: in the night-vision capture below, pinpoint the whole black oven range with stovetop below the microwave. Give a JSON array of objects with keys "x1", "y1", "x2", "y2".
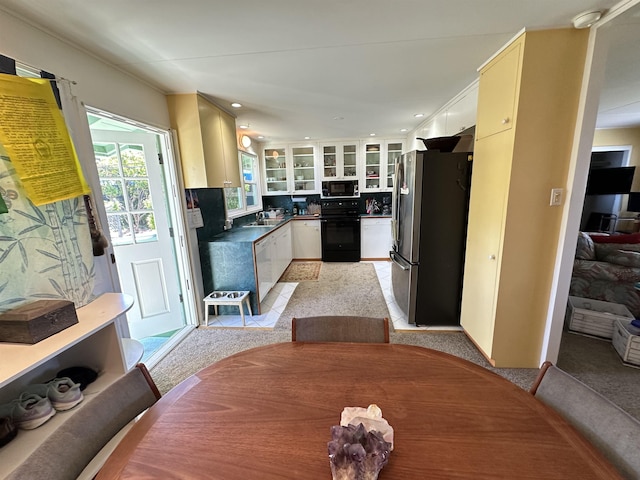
[{"x1": 320, "y1": 200, "x2": 360, "y2": 262}]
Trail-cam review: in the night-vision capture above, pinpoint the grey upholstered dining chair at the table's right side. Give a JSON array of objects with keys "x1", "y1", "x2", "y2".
[{"x1": 530, "y1": 362, "x2": 640, "y2": 479}]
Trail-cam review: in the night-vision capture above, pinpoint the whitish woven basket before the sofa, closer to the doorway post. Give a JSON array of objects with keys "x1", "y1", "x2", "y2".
[{"x1": 567, "y1": 297, "x2": 634, "y2": 339}]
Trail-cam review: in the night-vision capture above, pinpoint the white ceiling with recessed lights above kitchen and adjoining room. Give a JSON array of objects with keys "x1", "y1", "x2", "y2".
[{"x1": 0, "y1": 0, "x2": 640, "y2": 142}]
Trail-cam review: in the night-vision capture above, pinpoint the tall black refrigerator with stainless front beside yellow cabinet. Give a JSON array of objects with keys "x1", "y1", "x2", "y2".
[{"x1": 389, "y1": 150, "x2": 473, "y2": 326}]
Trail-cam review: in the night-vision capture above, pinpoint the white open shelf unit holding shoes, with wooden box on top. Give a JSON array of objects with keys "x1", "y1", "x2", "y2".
[{"x1": 0, "y1": 293, "x2": 133, "y2": 478}]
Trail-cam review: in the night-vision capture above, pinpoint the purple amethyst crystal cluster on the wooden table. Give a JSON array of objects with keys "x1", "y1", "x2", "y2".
[{"x1": 327, "y1": 423, "x2": 391, "y2": 480}]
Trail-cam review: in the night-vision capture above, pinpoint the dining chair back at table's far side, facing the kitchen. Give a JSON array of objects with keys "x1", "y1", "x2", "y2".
[{"x1": 291, "y1": 315, "x2": 389, "y2": 343}]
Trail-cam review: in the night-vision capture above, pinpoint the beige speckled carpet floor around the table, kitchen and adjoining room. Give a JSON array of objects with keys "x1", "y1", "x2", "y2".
[{"x1": 151, "y1": 263, "x2": 640, "y2": 418}]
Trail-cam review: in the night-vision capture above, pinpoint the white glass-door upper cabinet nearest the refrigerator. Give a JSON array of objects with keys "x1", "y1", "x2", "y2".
[{"x1": 360, "y1": 140, "x2": 404, "y2": 194}]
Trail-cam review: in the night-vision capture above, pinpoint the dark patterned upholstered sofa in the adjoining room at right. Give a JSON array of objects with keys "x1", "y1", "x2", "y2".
[{"x1": 569, "y1": 232, "x2": 640, "y2": 318}]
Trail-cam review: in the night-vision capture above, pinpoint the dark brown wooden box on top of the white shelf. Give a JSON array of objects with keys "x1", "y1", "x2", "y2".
[{"x1": 0, "y1": 300, "x2": 78, "y2": 343}]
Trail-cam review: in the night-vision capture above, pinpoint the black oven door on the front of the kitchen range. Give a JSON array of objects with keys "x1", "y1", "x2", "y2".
[{"x1": 321, "y1": 217, "x2": 360, "y2": 262}]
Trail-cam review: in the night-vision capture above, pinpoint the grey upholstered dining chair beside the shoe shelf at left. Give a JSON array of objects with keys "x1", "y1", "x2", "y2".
[{"x1": 7, "y1": 363, "x2": 161, "y2": 480}]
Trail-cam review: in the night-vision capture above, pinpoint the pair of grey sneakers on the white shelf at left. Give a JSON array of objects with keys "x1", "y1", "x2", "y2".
[{"x1": 0, "y1": 377, "x2": 84, "y2": 430}]
